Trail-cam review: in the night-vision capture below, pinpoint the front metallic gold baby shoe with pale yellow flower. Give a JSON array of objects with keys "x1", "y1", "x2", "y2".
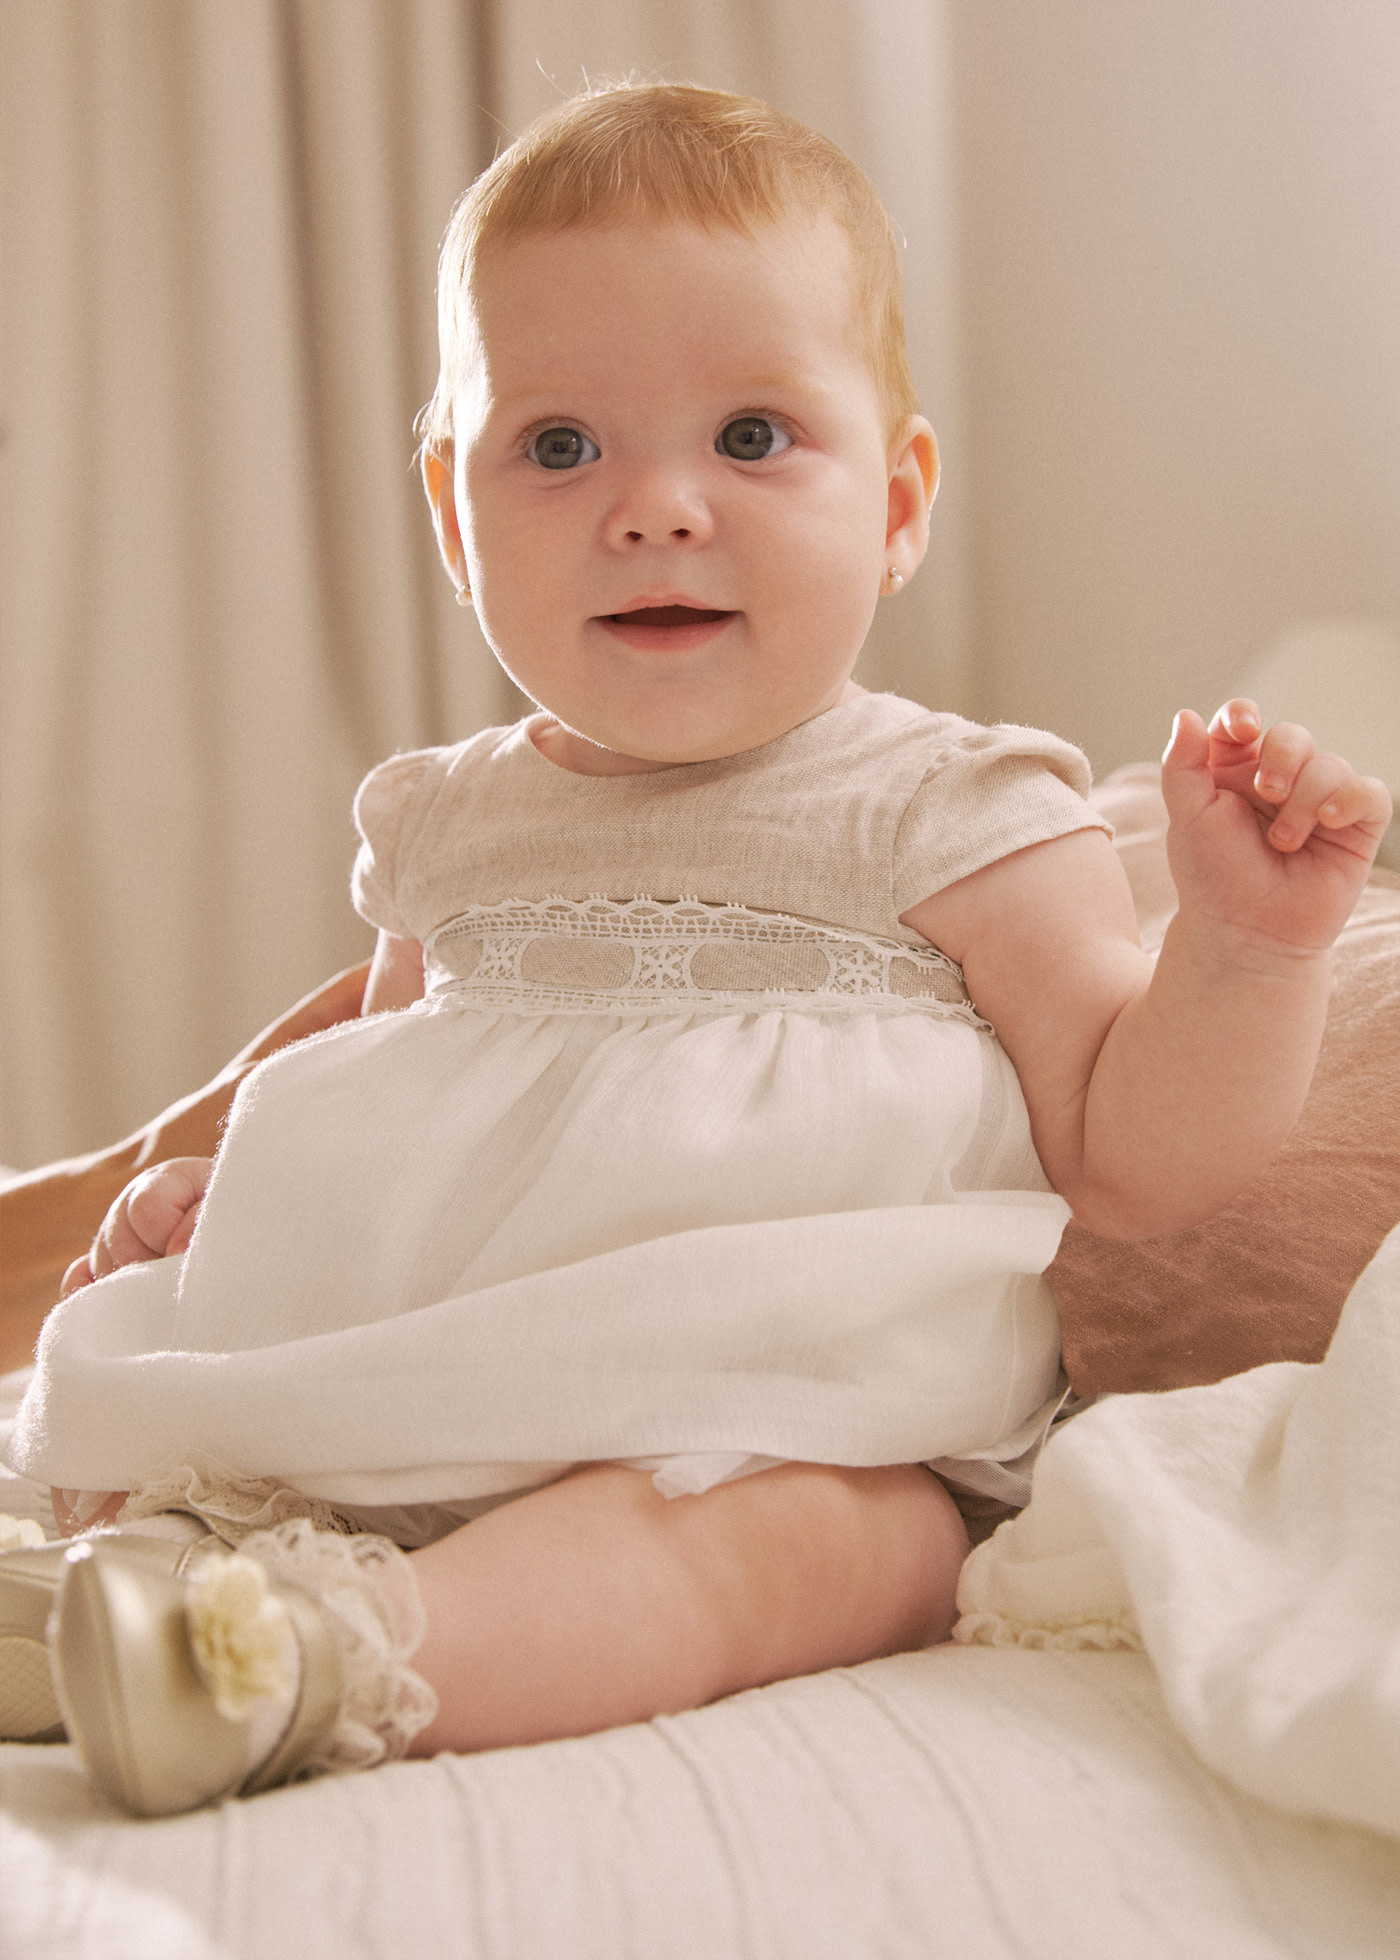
[{"x1": 49, "y1": 1537, "x2": 341, "y2": 1817}]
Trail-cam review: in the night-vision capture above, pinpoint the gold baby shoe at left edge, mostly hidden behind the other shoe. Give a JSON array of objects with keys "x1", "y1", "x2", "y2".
[{"x1": 0, "y1": 1517, "x2": 218, "y2": 1742}]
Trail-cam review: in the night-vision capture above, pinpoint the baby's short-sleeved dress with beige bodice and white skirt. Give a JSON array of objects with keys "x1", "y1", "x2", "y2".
[{"x1": 10, "y1": 694, "x2": 1102, "y2": 1543}]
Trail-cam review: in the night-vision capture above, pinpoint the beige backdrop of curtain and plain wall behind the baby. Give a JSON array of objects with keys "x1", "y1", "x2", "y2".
[{"x1": 0, "y1": 0, "x2": 1400, "y2": 1164}]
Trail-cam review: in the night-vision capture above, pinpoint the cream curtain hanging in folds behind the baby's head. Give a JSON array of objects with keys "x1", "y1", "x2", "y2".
[{"x1": 0, "y1": 0, "x2": 965, "y2": 1166}]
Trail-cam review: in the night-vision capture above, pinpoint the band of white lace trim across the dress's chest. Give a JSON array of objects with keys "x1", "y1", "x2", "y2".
[{"x1": 425, "y1": 898, "x2": 990, "y2": 1031}]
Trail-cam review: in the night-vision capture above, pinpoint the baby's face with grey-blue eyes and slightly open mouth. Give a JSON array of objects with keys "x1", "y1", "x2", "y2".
[{"x1": 439, "y1": 218, "x2": 925, "y2": 774}]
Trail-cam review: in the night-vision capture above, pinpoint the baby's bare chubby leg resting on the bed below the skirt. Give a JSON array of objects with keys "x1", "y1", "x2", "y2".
[{"x1": 412, "y1": 1464, "x2": 967, "y2": 1756}]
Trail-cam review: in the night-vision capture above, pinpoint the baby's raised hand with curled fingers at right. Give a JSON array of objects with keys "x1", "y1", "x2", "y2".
[{"x1": 1163, "y1": 700, "x2": 1390, "y2": 951}]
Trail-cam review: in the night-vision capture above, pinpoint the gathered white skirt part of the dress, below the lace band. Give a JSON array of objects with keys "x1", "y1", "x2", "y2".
[{"x1": 10, "y1": 901, "x2": 1069, "y2": 1511}]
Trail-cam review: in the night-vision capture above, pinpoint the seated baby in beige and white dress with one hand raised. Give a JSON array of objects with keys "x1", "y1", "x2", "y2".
[{"x1": 0, "y1": 86, "x2": 1388, "y2": 1811}]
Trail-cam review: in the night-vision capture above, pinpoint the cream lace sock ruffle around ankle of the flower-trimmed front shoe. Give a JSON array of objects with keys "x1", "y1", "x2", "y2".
[{"x1": 239, "y1": 1517, "x2": 437, "y2": 1778}]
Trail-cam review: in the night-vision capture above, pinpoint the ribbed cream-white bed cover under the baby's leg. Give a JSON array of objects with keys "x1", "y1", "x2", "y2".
[{"x1": 0, "y1": 1364, "x2": 1400, "y2": 1960}]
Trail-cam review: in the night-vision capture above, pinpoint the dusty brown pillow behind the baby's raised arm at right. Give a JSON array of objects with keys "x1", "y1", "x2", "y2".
[{"x1": 1049, "y1": 764, "x2": 1400, "y2": 1396}]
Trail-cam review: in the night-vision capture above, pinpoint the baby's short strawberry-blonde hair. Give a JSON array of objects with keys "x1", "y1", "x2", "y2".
[{"x1": 418, "y1": 82, "x2": 920, "y2": 451}]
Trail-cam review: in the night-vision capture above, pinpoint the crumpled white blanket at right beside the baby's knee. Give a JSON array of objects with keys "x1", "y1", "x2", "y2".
[{"x1": 955, "y1": 1227, "x2": 1400, "y2": 1835}]
